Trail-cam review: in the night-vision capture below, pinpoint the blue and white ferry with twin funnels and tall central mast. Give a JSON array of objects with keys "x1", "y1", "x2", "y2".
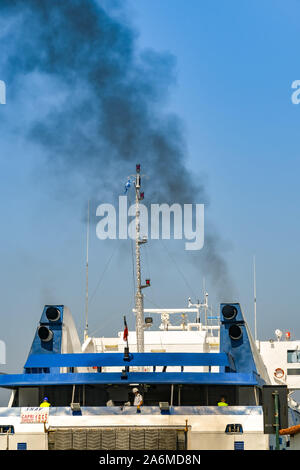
[{"x1": 0, "y1": 165, "x2": 300, "y2": 451}]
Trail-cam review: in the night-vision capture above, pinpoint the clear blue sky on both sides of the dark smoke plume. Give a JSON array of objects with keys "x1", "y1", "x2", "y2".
[{"x1": 0, "y1": 0, "x2": 300, "y2": 404}]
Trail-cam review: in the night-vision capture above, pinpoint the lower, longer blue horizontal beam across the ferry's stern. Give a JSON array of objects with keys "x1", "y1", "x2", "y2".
[{"x1": 0, "y1": 372, "x2": 259, "y2": 388}]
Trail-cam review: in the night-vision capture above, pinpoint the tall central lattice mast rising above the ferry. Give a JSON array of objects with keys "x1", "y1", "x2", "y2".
[{"x1": 135, "y1": 172, "x2": 144, "y2": 352}]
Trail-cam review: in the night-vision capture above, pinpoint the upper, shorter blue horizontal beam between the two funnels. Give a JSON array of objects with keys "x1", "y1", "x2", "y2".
[{"x1": 25, "y1": 353, "x2": 232, "y2": 368}]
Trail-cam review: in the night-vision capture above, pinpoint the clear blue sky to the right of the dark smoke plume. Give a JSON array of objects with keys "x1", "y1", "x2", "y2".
[{"x1": 132, "y1": 0, "x2": 300, "y2": 330}]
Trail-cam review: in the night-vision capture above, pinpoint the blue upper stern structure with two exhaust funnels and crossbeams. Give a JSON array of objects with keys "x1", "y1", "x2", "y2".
[{"x1": 0, "y1": 304, "x2": 269, "y2": 406}]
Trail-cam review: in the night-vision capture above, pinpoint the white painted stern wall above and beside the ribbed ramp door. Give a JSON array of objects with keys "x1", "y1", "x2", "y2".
[{"x1": 0, "y1": 407, "x2": 269, "y2": 450}]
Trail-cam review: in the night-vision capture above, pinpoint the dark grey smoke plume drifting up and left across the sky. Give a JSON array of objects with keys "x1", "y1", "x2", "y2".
[{"x1": 0, "y1": 0, "x2": 233, "y2": 298}]
